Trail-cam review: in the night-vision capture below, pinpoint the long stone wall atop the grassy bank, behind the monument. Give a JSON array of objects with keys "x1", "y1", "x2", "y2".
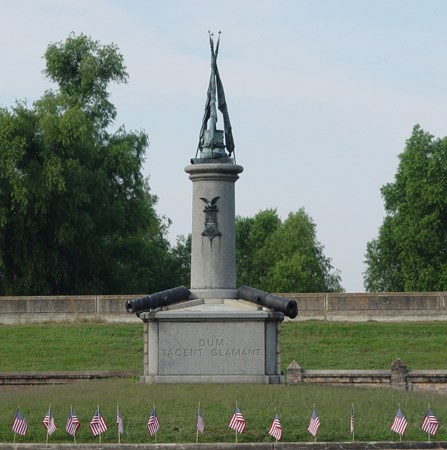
[{"x1": 0, "y1": 292, "x2": 447, "y2": 324}]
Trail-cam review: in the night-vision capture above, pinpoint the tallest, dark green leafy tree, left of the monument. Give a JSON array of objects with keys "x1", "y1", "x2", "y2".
[{"x1": 0, "y1": 34, "x2": 175, "y2": 295}]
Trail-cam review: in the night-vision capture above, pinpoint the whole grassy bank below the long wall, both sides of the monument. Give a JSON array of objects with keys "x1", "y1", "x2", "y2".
[{"x1": 0, "y1": 321, "x2": 447, "y2": 373}]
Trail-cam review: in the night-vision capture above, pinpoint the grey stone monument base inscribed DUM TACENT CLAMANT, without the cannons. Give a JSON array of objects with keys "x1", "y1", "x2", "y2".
[{"x1": 140, "y1": 298, "x2": 284, "y2": 384}]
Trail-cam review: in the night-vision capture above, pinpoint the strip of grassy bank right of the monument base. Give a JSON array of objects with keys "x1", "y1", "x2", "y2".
[{"x1": 281, "y1": 322, "x2": 447, "y2": 370}]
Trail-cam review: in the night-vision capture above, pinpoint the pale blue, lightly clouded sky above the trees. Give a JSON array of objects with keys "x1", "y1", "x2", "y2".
[{"x1": 0, "y1": 0, "x2": 447, "y2": 292}]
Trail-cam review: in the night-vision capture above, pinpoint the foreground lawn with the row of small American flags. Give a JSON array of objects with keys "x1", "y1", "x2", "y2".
[{"x1": 0, "y1": 379, "x2": 447, "y2": 443}]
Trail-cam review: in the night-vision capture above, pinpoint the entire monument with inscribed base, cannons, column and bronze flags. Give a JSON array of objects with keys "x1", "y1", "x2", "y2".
[{"x1": 126, "y1": 32, "x2": 297, "y2": 384}]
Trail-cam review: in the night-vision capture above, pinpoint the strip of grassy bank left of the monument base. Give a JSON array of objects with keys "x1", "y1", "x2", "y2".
[{"x1": 0, "y1": 322, "x2": 143, "y2": 372}]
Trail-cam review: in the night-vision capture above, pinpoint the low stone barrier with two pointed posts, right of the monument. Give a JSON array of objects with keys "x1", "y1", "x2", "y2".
[{"x1": 286, "y1": 359, "x2": 447, "y2": 393}]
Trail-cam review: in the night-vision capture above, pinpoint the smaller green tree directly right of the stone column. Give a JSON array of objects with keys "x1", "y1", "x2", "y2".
[{"x1": 236, "y1": 209, "x2": 342, "y2": 292}]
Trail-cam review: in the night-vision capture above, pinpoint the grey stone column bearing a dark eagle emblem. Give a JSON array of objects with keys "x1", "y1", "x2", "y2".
[{"x1": 185, "y1": 159, "x2": 243, "y2": 299}]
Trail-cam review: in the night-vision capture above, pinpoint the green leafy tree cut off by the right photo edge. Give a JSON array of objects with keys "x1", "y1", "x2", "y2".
[{"x1": 364, "y1": 125, "x2": 447, "y2": 292}]
